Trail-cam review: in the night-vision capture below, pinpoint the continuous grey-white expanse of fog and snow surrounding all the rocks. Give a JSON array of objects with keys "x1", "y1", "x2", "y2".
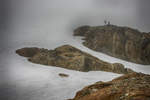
[{"x1": 0, "y1": 0, "x2": 150, "y2": 100}]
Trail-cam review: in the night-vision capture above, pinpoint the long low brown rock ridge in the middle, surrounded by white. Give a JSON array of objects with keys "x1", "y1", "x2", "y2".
[{"x1": 17, "y1": 45, "x2": 133, "y2": 74}]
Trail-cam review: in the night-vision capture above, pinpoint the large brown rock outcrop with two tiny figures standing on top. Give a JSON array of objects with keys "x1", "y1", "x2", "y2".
[{"x1": 74, "y1": 25, "x2": 150, "y2": 64}]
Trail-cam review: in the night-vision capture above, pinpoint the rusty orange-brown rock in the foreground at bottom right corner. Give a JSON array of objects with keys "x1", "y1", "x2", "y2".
[{"x1": 69, "y1": 73, "x2": 150, "y2": 100}]
